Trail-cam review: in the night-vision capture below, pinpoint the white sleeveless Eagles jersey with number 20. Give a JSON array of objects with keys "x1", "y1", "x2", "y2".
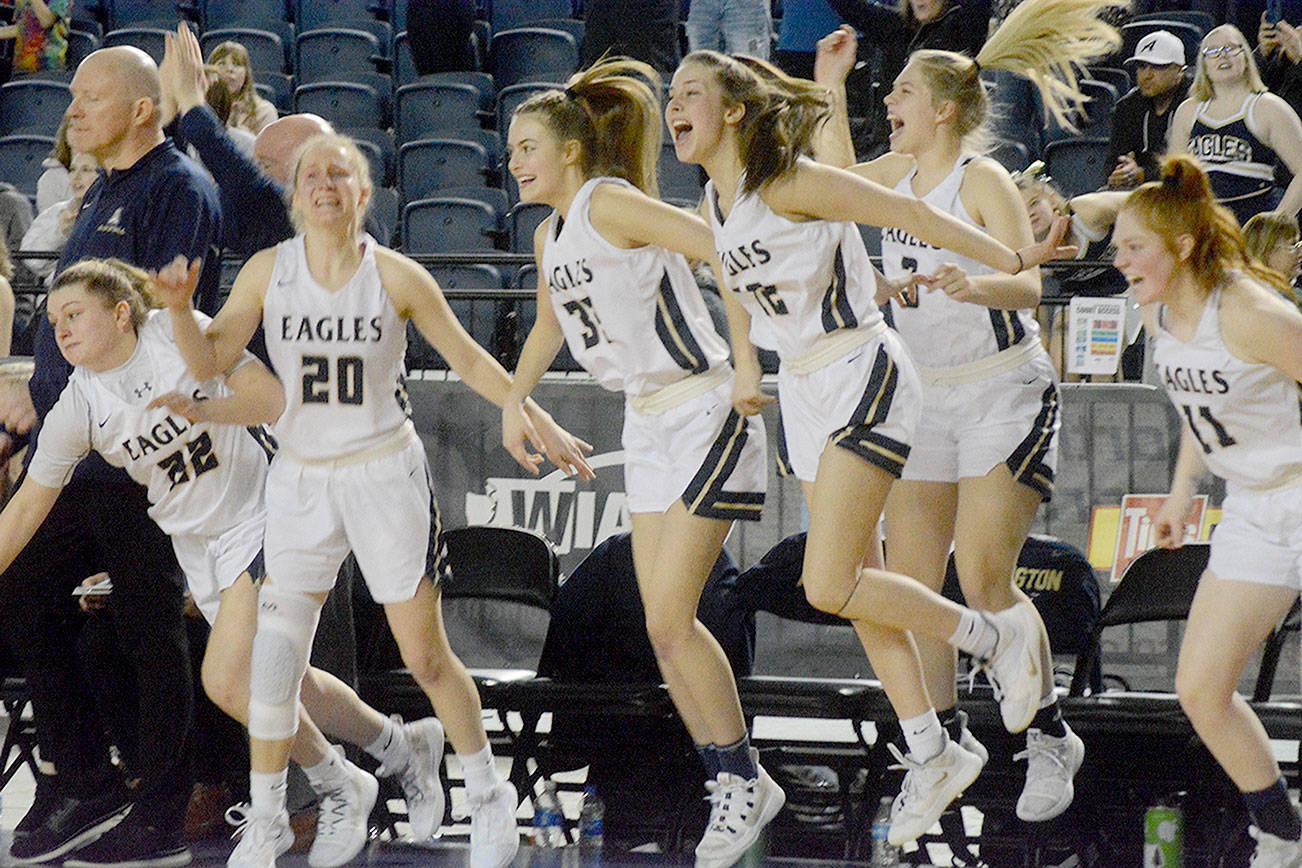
[{"x1": 262, "y1": 236, "x2": 408, "y2": 461}]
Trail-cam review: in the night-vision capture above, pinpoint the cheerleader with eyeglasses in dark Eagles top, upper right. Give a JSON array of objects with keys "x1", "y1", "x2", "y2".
[{"x1": 1170, "y1": 25, "x2": 1302, "y2": 225}]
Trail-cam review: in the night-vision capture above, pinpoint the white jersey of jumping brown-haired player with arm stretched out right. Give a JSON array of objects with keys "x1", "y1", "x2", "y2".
[{"x1": 706, "y1": 166, "x2": 881, "y2": 359}]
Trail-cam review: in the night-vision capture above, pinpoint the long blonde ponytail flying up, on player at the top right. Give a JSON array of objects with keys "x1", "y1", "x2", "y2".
[{"x1": 909, "y1": 0, "x2": 1129, "y2": 150}]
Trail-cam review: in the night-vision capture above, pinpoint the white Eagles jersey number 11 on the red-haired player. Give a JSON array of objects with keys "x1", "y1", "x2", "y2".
[{"x1": 1154, "y1": 283, "x2": 1302, "y2": 489}]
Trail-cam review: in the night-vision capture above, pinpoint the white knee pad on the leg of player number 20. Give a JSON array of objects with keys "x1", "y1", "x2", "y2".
[{"x1": 249, "y1": 584, "x2": 320, "y2": 742}]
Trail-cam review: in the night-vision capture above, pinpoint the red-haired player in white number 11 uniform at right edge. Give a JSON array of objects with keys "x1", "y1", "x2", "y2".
[{"x1": 1113, "y1": 156, "x2": 1302, "y2": 868}]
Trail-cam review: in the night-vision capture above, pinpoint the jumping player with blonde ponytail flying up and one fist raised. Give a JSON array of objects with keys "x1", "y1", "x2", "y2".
[{"x1": 819, "y1": 0, "x2": 1120, "y2": 822}]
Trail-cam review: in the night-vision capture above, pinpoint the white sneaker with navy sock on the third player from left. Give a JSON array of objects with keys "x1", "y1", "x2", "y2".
[{"x1": 697, "y1": 748, "x2": 786, "y2": 868}]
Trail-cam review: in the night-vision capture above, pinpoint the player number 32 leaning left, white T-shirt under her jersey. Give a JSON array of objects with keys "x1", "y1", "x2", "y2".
[{"x1": 0, "y1": 260, "x2": 441, "y2": 868}]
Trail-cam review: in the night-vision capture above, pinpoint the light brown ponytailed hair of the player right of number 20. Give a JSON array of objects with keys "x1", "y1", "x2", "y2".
[{"x1": 513, "y1": 57, "x2": 664, "y2": 197}]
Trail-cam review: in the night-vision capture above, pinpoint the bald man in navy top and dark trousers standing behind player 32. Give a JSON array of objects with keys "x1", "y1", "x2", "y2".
[{"x1": 0, "y1": 47, "x2": 221, "y2": 868}]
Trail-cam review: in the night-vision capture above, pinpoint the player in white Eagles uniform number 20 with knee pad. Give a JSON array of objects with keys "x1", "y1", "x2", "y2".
[{"x1": 159, "y1": 135, "x2": 591, "y2": 868}]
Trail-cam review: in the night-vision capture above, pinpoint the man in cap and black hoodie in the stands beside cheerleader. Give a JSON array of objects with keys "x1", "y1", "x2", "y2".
[{"x1": 1108, "y1": 30, "x2": 1189, "y2": 190}]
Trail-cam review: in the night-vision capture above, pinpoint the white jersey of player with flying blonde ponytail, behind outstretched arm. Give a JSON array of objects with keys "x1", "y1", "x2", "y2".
[{"x1": 881, "y1": 155, "x2": 1039, "y2": 368}]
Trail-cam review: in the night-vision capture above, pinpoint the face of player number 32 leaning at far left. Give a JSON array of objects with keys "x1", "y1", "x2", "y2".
[{"x1": 48, "y1": 284, "x2": 135, "y2": 371}]
